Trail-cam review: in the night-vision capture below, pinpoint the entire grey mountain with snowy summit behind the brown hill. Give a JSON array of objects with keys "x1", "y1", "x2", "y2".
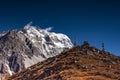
[{"x1": 0, "y1": 24, "x2": 73, "y2": 79}]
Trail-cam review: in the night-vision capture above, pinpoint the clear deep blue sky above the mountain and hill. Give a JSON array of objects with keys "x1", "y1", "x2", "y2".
[{"x1": 0, "y1": 0, "x2": 120, "y2": 56}]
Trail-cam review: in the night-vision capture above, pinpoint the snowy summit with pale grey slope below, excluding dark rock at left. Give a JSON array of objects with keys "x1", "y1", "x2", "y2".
[{"x1": 19, "y1": 24, "x2": 72, "y2": 67}]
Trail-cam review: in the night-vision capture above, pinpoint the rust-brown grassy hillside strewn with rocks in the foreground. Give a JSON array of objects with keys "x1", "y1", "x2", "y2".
[{"x1": 7, "y1": 42, "x2": 120, "y2": 80}]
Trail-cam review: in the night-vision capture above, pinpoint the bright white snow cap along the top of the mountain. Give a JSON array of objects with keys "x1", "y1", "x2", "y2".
[{"x1": 23, "y1": 24, "x2": 73, "y2": 48}]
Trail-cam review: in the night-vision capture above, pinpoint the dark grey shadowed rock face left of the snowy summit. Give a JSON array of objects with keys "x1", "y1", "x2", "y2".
[{"x1": 0, "y1": 31, "x2": 31, "y2": 73}]
